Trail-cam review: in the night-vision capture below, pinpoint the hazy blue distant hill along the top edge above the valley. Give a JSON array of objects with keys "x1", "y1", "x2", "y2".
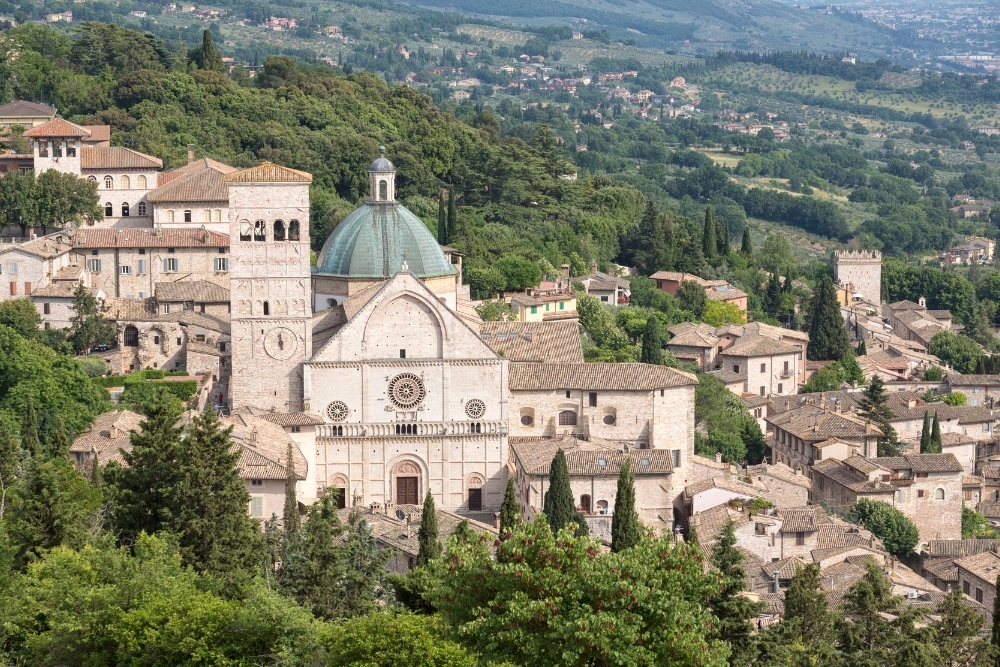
[{"x1": 402, "y1": 0, "x2": 894, "y2": 57}]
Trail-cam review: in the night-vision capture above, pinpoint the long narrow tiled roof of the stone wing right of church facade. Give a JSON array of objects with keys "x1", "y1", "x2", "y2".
[{"x1": 509, "y1": 363, "x2": 698, "y2": 391}]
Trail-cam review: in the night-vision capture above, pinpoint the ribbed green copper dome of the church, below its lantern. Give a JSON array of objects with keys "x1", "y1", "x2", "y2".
[{"x1": 314, "y1": 202, "x2": 458, "y2": 278}]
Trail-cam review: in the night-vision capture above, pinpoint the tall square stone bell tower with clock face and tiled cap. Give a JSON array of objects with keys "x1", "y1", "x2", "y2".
[{"x1": 226, "y1": 163, "x2": 312, "y2": 412}]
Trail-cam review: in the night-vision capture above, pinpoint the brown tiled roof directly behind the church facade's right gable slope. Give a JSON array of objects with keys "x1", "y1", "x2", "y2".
[{"x1": 479, "y1": 322, "x2": 583, "y2": 364}]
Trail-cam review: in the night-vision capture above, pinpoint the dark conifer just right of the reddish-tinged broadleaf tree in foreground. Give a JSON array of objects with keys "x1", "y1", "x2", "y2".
[{"x1": 708, "y1": 519, "x2": 763, "y2": 666}]
